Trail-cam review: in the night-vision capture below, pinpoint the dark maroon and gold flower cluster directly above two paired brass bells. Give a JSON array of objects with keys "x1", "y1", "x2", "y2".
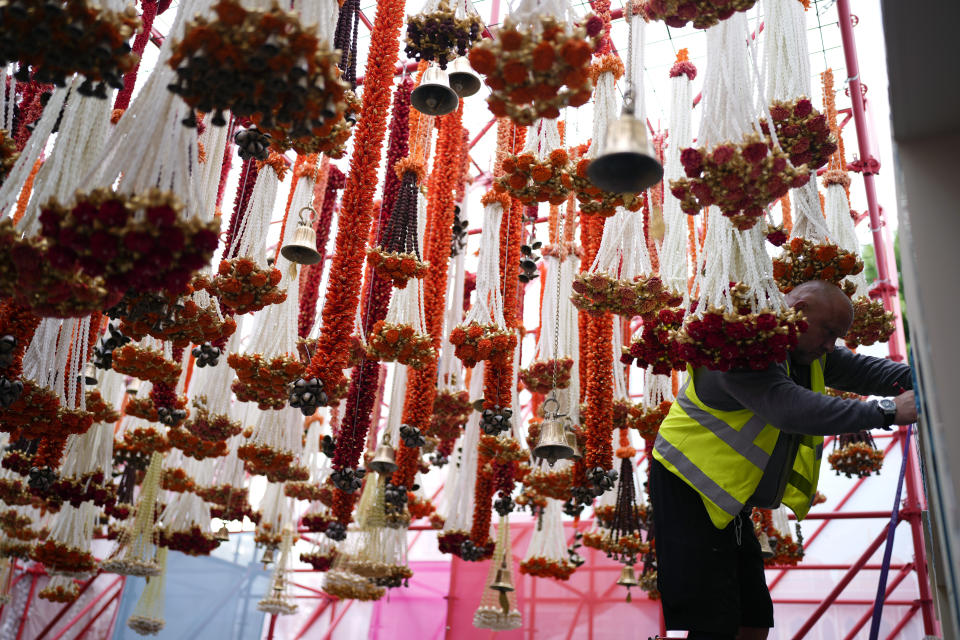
[{"x1": 404, "y1": 0, "x2": 484, "y2": 69}]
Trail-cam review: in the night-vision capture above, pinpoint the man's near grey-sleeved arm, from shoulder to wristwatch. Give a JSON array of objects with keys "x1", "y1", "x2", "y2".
[{"x1": 698, "y1": 365, "x2": 885, "y2": 435}]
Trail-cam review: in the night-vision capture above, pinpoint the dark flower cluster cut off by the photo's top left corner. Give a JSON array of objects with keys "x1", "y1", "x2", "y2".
[{"x1": 0, "y1": 0, "x2": 140, "y2": 98}]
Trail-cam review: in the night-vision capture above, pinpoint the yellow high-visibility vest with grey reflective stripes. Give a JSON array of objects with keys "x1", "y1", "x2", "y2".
[{"x1": 653, "y1": 358, "x2": 826, "y2": 529}]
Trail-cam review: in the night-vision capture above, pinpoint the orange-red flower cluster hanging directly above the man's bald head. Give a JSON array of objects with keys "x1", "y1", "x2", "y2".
[{"x1": 773, "y1": 237, "x2": 863, "y2": 293}]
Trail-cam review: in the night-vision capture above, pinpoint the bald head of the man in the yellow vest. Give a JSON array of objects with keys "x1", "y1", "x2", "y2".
[{"x1": 786, "y1": 280, "x2": 853, "y2": 364}]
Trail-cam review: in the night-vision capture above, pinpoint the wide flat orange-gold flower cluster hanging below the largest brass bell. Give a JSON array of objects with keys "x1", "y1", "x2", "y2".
[{"x1": 570, "y1": 272, "x2": 683, "y2": 318}]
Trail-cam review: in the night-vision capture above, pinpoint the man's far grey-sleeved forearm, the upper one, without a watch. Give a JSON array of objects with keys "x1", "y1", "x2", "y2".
[{"x1": 823, "y1": 347, "x2": 913, "y2": 396}]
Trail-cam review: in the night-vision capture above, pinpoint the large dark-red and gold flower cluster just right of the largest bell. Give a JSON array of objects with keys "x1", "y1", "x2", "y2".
[{"x1": 670, "y1": 133, "x2": 810, "y2": 231}]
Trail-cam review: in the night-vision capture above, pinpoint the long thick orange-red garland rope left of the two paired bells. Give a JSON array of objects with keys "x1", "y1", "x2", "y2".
[{"x1": 304, "y1": 0, "x2": 404, "y2": 403}]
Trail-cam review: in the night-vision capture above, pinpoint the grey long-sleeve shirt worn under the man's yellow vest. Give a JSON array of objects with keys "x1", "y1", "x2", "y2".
[{"x1": 696, "y1": 347, "x2": 913, "y2": 508}]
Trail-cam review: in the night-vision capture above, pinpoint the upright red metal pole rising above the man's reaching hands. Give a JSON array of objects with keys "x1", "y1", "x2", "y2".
[{"x1": 837, "y1": 0, "x2": 906, "y2": 362}]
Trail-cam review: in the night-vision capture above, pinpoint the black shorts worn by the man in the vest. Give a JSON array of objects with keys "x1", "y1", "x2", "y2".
[{"x1": 650, "y1": 460, "x2": 773, "y2": 637}]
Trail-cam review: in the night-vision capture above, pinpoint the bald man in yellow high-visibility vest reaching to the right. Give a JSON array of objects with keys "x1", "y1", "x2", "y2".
[{"x1": 650, "y1": 281, "x2": 917, "y2": 640}]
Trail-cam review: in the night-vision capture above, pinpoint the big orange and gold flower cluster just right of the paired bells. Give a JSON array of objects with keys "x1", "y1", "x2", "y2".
[{"x1": 469, "y1": 14, "x2": 603, "y2": 125}]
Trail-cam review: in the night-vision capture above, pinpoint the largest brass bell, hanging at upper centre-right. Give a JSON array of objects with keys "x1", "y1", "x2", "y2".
[{"x1": 587, "y1": 95, "x2": 663, "y2": 193}]
